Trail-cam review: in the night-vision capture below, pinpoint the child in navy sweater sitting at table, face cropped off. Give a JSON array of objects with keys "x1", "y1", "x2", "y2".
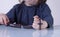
[{"x1": 0, "y1": 0, "x2": 53, "y2": 29}]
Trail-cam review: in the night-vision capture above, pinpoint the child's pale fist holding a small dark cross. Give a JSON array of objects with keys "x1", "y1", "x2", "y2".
[{"x1": 32, "y1": 15, "x2": 48, "y2": 30}]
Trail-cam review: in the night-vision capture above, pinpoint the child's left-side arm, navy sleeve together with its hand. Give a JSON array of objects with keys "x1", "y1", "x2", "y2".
[{"x1": 0, "y1": 4, "x2": 20, "y2": 25}]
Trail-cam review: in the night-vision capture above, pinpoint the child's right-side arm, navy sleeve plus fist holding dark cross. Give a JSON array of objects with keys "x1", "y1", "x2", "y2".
[{"x1": 32, "y1": 4, "x2": 53, "y2": 29}]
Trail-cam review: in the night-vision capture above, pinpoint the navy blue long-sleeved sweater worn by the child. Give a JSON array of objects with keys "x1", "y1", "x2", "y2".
[{"x1": 6, "y1": 3, "x2": 53, "y2": 27}]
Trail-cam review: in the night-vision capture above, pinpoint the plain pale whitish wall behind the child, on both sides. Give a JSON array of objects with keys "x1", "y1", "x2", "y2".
[{"x1": 0, "y1": 0, "x2": 60, "y2": 26}]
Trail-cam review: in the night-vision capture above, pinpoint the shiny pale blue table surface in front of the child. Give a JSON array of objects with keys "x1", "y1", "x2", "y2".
[{"x1": 0, "y1": 25, "x2": 60, "y2": 37}]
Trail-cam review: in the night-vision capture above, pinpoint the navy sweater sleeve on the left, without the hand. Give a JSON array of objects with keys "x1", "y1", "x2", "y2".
[{"x1": 6, "y1": 4, "x2": 19, "y2": 23}]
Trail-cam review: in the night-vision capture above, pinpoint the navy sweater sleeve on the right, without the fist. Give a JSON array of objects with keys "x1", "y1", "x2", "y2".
[{"x1": 42, "y1": 4, "x2": 53, "y2": 28}]
